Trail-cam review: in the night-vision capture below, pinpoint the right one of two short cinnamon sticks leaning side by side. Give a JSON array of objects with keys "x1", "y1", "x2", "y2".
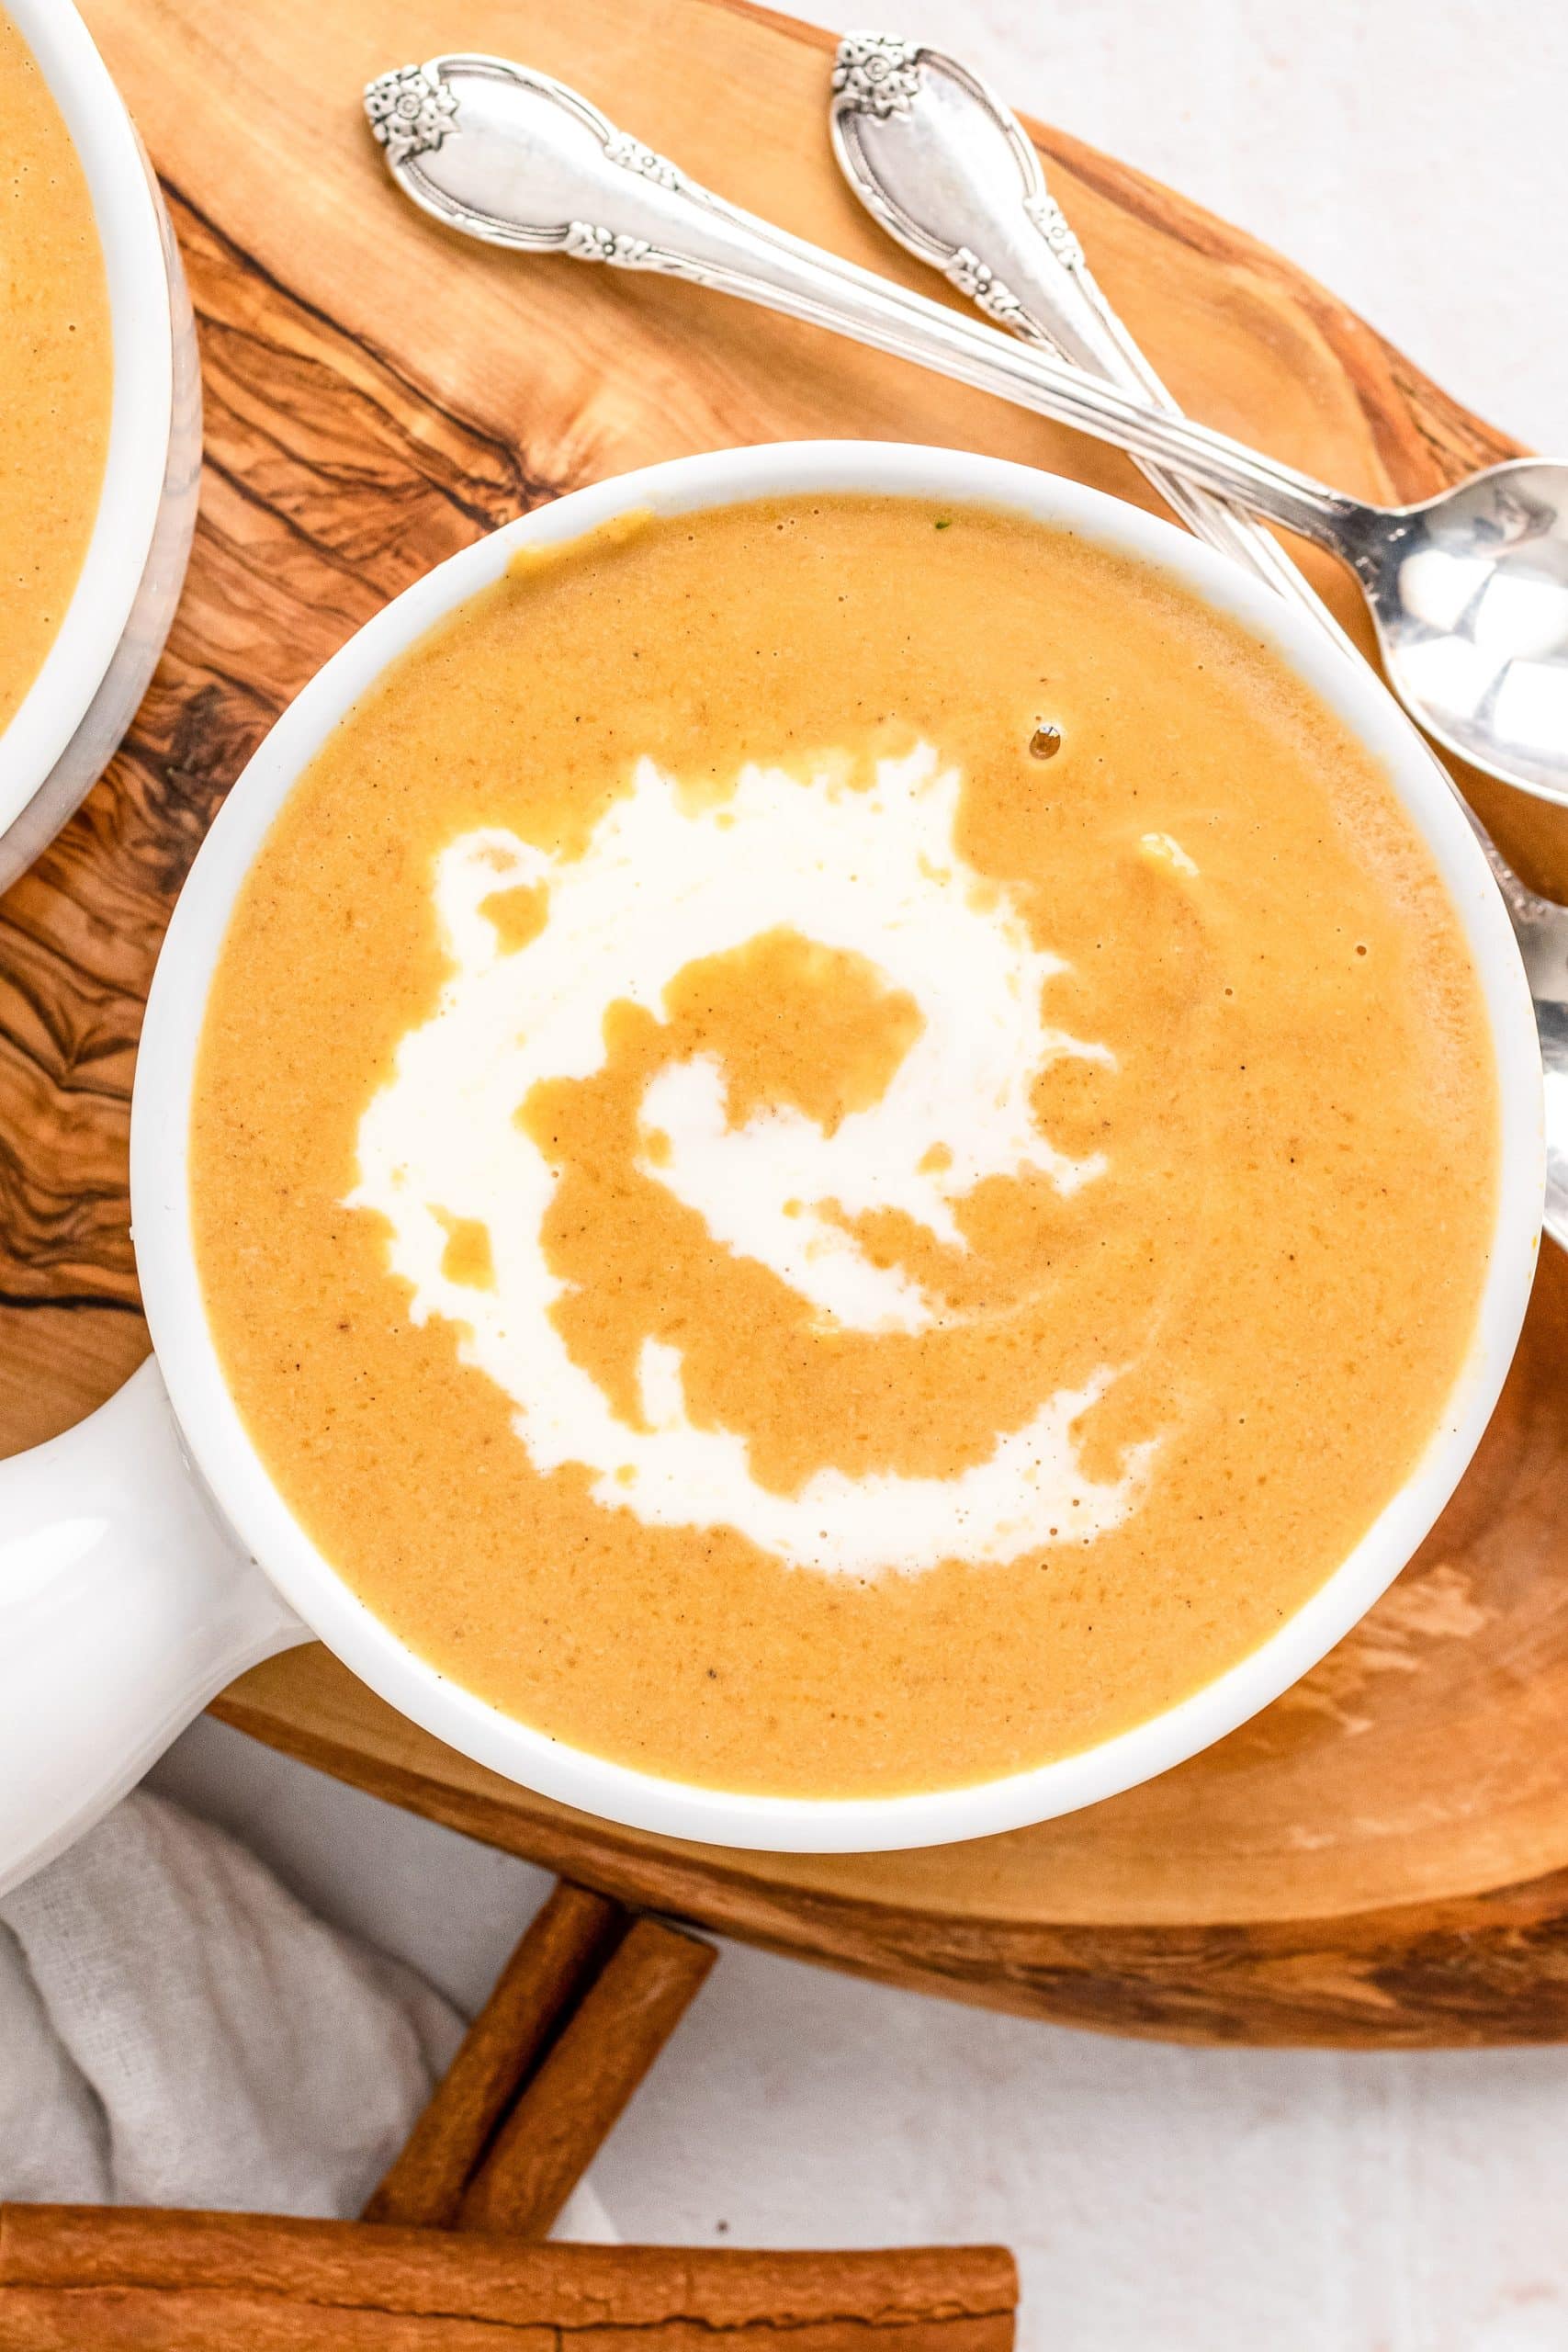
[{"x1": 458, "y1": 1919, "x2": 717, "y2": 2237}]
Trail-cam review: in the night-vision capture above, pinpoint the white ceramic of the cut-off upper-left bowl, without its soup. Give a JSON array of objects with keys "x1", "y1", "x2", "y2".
[{"x1": 0, "y1": 0, "x2": 202, "y2": 889}]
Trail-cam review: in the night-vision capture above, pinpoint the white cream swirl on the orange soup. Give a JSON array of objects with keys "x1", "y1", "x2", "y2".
[{"x1": 350, "y1": 743, "x2": 1149, "y2": 1576}]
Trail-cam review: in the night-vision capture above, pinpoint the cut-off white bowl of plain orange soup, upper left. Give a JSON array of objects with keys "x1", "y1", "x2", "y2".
[{"x1": 0, "y1": 0, "x2": 200, "y2": 887}]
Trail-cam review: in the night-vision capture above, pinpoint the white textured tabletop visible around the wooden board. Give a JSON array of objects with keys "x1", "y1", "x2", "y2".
[{"x1": 155, "y1": 0, "x2": 1568, "y2": 2352}]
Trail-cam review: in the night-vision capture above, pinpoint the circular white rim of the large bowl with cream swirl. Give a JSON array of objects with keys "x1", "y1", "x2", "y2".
[{"x1": 131, "y1": 442, "x2": 1544, "y2": 1853}]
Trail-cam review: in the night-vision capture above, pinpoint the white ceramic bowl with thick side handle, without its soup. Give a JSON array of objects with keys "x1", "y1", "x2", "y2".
[{"x1": 0, "y1": 442, "x2": 1542, "y2": 1874}]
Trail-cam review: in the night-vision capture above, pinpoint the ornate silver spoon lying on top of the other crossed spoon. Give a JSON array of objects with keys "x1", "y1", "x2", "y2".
[{"x1": 365, "y1": 56, "x2": 1568, "y2": 802}]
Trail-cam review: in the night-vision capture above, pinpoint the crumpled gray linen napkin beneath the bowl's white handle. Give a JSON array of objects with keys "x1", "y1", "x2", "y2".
[{"x1": 0, "y1": 1790, "x2": 463, "y2": 2216}]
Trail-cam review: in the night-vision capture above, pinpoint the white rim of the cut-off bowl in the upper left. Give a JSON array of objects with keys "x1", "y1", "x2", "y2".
[{"x1": 0, "y1": 0, "x2": 174, "y2": 832}]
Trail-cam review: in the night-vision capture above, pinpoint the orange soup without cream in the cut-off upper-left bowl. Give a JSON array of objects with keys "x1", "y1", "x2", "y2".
[{"x1": 0, "y1": 12, "x2": 110, "y2": 727}]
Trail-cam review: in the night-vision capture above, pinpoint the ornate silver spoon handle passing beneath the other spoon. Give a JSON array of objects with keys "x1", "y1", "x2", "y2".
[{"x1": 832, "y1": 33, "x2": 1342, "y2": 638}]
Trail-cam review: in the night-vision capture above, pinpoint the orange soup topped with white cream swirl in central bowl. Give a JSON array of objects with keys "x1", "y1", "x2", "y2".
[{"x1": 190, "y1": 496, "x2": 1497, "y2": 1797}]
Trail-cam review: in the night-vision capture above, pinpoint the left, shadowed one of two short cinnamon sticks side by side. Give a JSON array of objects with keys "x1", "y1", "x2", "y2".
[{"x1": 365, "y1": 1879, "x2": 626, "y2": 2230}]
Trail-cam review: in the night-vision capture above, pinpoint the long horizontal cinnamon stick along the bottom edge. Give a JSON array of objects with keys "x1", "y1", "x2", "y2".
[{"x1": 0, "y1": 2206, "x2": 1018, "y2": 2352}]
